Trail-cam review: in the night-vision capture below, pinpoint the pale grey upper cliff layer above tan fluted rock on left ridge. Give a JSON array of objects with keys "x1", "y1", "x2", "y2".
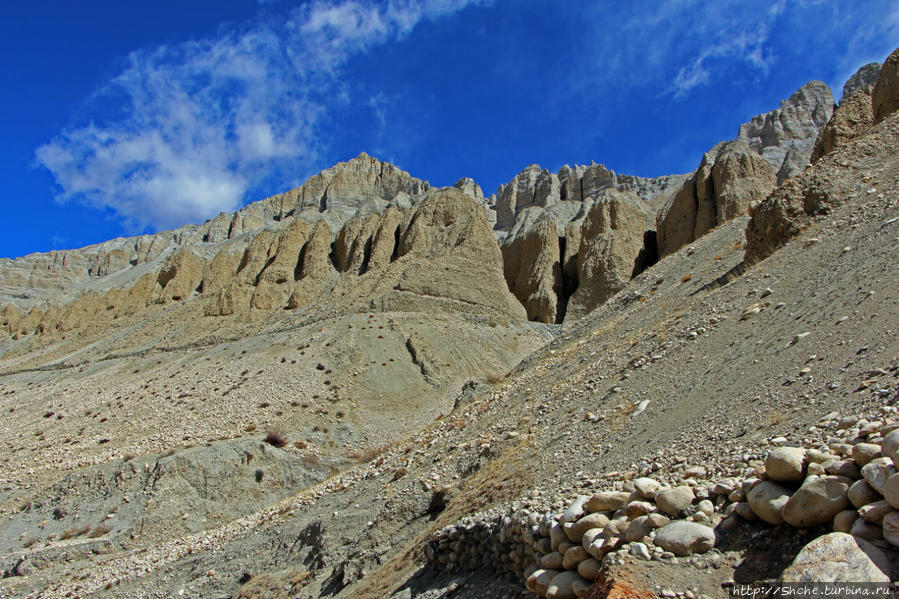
[{"x1": 0, "y1": 153, "x2": 430, "y2": 308}]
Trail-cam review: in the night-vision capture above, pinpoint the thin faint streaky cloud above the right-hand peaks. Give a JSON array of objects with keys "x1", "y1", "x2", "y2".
[{"x1": 556, "y1": 0, "x2": 899, "y2": 109}]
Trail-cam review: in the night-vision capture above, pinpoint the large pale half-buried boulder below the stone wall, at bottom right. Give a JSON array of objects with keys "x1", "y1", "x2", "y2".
[{"x1": 781, "y1": 532, "x2": 890, "y2": 582}]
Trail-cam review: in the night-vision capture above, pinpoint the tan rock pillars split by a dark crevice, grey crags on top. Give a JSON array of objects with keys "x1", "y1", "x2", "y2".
[{"x1": 488, "y1": 163, "x2": 686, "y2": 323}]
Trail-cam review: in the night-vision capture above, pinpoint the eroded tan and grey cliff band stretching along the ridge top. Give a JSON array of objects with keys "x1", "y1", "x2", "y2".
[{"x1": 0, "y1": 67, "x2": 856, "y2": 335}]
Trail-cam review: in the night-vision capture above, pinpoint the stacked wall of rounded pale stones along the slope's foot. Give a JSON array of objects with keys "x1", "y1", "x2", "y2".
[{"x1": 425, "y1": 419, "x2": 899, "y2": 599}]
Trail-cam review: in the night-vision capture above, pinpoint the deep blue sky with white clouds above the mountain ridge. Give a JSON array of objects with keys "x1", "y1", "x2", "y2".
[{"x1": 0, "y1": 0, "x2": 899, "y2": 257}]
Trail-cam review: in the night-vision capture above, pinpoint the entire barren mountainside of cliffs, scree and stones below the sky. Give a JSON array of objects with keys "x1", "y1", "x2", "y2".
[{"x1": 0, "y1": 52, "x2": 899, "y2": 599}]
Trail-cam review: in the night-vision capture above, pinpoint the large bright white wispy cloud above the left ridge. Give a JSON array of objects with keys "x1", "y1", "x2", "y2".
[{"x1": 36, "y1": 0, "x2": 485, "y2": 232}]
